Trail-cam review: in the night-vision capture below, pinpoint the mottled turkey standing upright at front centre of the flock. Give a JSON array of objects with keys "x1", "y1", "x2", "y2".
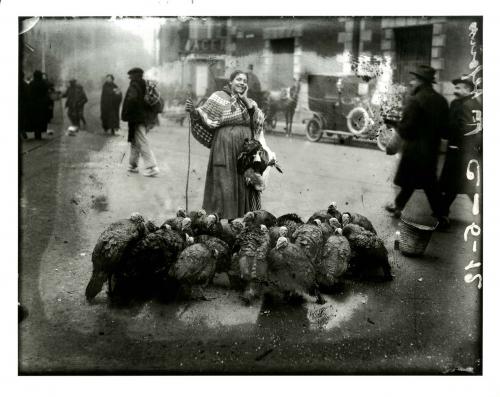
[{"x1": 233, "y1": 224, "x2": 269, "y2": 303}]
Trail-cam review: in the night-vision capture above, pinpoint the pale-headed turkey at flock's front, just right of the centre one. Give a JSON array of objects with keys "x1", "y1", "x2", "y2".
[{"x1": 266, "y1": 237, "x2": 325, "y2": 304}]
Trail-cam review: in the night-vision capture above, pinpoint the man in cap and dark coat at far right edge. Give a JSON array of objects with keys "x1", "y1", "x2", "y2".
[{"x1": 439, "y1": 78, "x2": 482, "y2": 215}]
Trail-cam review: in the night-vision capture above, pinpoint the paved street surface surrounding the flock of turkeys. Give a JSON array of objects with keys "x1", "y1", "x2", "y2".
[{"x1": 19, "y1": 103, "x2": 481, "y2": 374}]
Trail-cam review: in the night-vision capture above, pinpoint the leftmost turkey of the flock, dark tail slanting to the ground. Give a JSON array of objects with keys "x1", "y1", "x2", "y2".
[{"x1": 85, "y1": 213, "x2": 146, "y2": 301}]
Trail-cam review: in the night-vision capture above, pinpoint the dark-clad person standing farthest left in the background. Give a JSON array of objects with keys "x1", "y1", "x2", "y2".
[{"x1": 29, "y1": 70, "x2": 50, "y2": 139}]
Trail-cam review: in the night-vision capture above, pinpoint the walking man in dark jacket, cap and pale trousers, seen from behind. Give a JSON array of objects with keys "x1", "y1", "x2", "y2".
[{"x1": 122, "y1": 68, "x2": 160, "y2": 177}]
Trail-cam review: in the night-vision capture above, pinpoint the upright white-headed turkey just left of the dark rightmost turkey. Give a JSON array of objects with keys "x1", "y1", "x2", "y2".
[{"x1": 314, "y1": 229, "x2": 351, "y2": 290}]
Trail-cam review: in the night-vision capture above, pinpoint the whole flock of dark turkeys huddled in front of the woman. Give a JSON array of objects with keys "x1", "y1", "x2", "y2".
[{"x1": 85, "y1": 203, "x2": 392, "y2": 303}]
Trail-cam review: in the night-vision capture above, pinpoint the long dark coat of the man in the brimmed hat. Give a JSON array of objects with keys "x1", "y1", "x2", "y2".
[{"x1": 394, "y1": 84, "x2": 448, "y2": 189}]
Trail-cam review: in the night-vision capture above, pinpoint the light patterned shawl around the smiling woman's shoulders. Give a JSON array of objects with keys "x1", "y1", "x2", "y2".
[{"x1": 191, "y1": 90, "x2": 264, "y2": 147}]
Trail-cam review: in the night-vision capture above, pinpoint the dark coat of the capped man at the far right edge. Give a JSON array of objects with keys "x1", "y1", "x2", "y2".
[{"x1": 440, "y1": 96, "x2": 483, "y2": 194}]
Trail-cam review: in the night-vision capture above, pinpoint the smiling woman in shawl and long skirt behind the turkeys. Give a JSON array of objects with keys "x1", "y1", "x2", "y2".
[{"x1": 186, "y1": 70, "x2": 275, "y2": 219}]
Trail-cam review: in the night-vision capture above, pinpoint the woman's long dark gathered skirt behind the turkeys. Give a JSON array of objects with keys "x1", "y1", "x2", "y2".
[{"x1": 203, "y1": 125, "x2": 260, "y2": 219}]
